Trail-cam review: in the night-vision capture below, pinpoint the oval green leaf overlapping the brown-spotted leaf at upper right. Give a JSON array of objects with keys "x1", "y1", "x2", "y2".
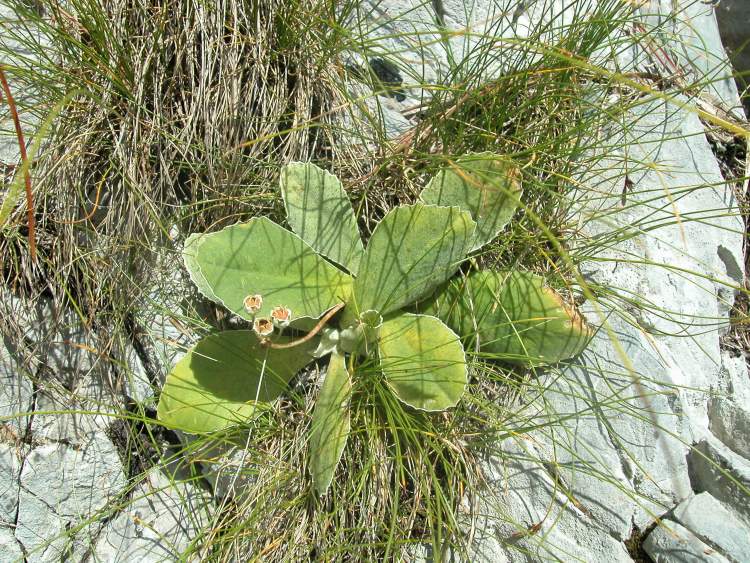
[{"x1": 354, "y1": 203, "x2": 475, "y2": 316}]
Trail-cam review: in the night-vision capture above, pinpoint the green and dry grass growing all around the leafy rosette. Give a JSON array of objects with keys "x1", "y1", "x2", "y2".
[{"x1": 0, "y1": 0, "x2": 747, "y2": 561}]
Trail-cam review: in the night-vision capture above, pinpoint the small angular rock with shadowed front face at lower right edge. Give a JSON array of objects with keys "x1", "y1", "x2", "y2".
[{"x1": 688, "y1": 435, "x2": 750, "y2": 525}]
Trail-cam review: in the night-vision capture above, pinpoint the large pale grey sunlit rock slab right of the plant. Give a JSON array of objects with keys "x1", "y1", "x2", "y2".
[{"x1": 478, "y1": 97, "x2": 742, "y2": 560}]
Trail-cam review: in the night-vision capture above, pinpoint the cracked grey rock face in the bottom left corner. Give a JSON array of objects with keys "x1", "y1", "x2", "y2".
[{"x1": 0, "y1": 293, "x2": 212, "y2": 562}]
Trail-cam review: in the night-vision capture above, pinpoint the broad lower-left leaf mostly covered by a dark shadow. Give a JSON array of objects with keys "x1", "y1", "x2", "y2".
[{"x1": 157, "y1": 330, "x2": 318, "y2": 433}]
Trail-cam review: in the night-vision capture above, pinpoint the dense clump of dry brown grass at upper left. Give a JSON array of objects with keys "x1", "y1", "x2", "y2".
[{"x1": 0, "y1": 0, "x2": 358, "y2": 340}]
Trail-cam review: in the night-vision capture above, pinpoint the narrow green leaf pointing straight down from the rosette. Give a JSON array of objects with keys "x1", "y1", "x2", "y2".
[{"x1": 310, "y1": 352, "x2": 352, "y2": 495}]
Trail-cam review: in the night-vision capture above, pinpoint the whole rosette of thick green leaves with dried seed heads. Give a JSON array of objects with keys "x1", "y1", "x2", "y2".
[{"x1": 158, "y1": 154, "x2": 592, "y2": 494}]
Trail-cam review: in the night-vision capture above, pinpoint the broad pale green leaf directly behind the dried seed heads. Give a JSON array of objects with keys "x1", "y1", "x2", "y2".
[{"x1": 183, "y1": 217, "x2": 352, "y2": 326}]
